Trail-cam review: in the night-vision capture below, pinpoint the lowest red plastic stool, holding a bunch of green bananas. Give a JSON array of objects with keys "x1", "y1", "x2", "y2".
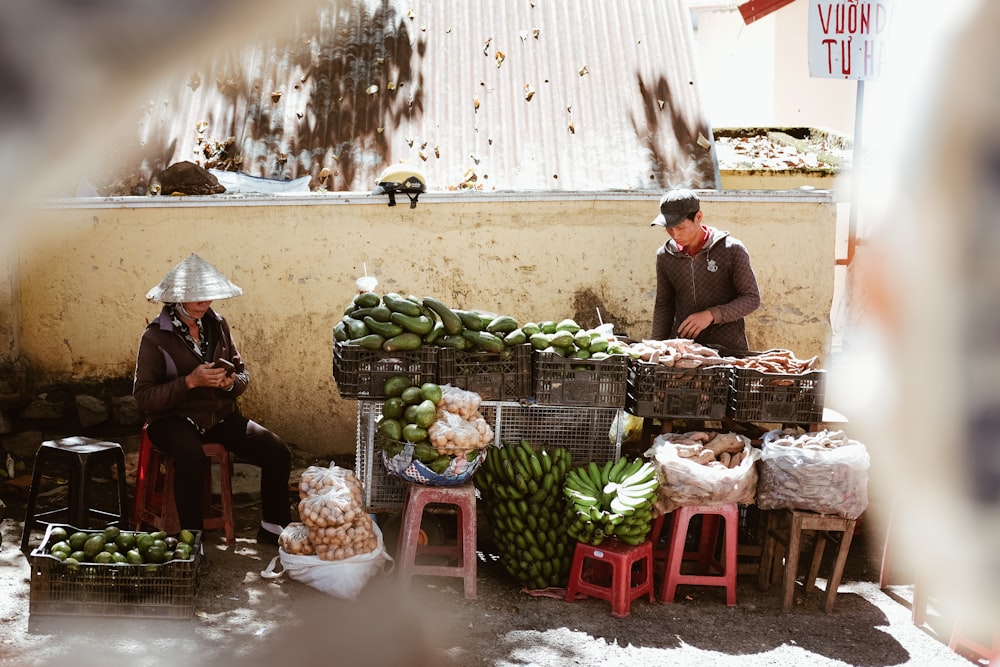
[{"x1": 566, "y1": 540, "x2": 654, "y2": 618}]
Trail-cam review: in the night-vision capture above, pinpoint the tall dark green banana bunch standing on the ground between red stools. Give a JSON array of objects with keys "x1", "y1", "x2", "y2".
[{"x1": 474, "y1": 440, "x2": 575, "y2": 588}]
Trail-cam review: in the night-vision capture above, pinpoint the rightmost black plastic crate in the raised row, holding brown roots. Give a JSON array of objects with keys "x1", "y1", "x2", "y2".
[{"x1": 732, "y1": 367, "x2": 826, "y2": 424}]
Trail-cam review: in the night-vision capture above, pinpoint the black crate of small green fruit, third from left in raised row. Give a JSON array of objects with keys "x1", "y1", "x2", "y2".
[{"x1": 534, "y1": 350, "x2": 628, "y2": 408}]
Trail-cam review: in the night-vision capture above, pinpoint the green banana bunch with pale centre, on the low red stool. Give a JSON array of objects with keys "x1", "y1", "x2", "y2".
[{"x1": 563, "y1": 456, "x2": 659, "y2": 546}]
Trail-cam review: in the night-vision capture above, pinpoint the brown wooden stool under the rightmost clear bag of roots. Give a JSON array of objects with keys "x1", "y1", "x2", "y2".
[{"x1": 757, "y1": 510, "x2": 855, "y2": 614}]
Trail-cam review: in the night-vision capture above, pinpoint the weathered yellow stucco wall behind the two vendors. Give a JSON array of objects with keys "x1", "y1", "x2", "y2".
[{"x1": 14, "y1": 191, "x2": 836, "y2": 454}]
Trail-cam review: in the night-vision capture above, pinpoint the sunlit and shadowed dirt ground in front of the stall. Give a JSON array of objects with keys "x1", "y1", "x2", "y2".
[{"x1": 0, "y1": 462, "x2": 975, "y2": 667}]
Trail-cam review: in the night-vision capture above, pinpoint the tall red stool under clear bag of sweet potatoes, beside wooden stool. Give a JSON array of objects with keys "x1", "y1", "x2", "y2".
[{"x1": 652, "y1": 503, "x2": 740, "y2": 607}]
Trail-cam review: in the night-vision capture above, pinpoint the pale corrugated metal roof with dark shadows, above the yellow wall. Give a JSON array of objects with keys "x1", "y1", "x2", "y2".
[{"x1": 133, "y1": 0, "x2": 719, "y2": 196}]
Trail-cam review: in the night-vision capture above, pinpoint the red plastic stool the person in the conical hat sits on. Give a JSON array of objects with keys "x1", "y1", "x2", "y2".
[{"x1": 132, "y1": 426, "x2": 236, "y2": 544}]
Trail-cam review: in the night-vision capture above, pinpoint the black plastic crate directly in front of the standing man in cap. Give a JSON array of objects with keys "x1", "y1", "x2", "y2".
[{"x1": 625, "y1": 359, "x2": 733, "y2": 419}]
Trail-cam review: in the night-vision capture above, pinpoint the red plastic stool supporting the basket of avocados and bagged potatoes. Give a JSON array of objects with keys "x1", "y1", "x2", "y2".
[{"x1": 396, "y1": 482, "x2": 476, "y2": 599}]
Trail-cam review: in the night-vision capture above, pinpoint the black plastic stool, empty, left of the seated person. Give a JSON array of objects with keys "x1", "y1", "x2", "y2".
[{"x1": 21, "y1": 436, "x2": 127, "y2": 555}]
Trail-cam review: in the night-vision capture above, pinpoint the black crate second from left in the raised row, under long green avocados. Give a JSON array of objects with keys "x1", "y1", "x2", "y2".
[{"x1": 437, "y1": 343, "x2": 533, "y2": 401}]
